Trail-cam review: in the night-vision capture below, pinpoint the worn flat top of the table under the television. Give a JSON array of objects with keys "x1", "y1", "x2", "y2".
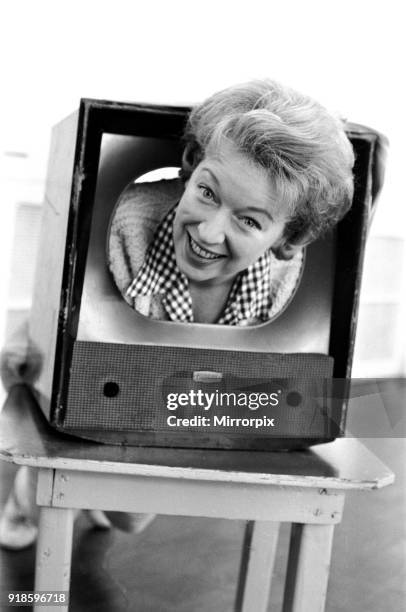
[{"x1": 0, "y1": 385, "x2": 394, "y2": 490}]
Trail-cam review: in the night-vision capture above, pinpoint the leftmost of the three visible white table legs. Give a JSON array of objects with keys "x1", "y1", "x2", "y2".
[{"x1": 34, "y1": 506, "x2": 74, "y2": 612}]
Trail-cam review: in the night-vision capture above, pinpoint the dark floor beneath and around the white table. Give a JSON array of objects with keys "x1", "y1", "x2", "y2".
[{"x1": 0, "y1": 383, "x2": 406, "y2": 612}]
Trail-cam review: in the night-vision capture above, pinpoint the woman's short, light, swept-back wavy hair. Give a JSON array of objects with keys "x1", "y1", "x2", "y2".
[{"x1": 182, "y1": 80, "x2": 354, "y2": 259}]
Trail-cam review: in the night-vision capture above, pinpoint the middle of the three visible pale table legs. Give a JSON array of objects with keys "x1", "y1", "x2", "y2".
[{"x1": 235, "y1": 521, "x2": 279, "y2": 612}]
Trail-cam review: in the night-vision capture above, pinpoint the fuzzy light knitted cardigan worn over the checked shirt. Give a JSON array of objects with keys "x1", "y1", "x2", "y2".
[{"x1": 109, "y1": 179, "x2": 304, "y2": 325}]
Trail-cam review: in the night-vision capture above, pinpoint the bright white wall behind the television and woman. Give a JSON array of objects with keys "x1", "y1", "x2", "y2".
[{"x1": 0, "y1": 0, "x2": 406, "y2": 376}]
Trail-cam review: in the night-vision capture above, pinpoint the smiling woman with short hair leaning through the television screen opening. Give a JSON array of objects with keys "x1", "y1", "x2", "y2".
[{"x1": 109, "y1": 81, "x2": 354, "y2": 325}]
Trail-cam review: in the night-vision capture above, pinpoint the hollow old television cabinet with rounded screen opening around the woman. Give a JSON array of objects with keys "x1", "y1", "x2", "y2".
[{"x1": 31, "y1": 100, "x2": 377, "y2": 449}]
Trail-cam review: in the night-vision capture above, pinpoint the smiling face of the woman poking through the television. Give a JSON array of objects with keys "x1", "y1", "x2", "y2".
[{"x1": 173, "y1": 142, "x2": 288, "y2": 285}]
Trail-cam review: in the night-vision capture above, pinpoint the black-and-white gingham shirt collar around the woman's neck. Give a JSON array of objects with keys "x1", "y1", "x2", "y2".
[{"x1": 127, "y1": 205, "x2": 272, "y2": 325}]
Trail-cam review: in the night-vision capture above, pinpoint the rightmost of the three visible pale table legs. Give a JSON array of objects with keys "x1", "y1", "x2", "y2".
[{"x1": 283, "y1": 524, "x2": 334, "y2": 612}]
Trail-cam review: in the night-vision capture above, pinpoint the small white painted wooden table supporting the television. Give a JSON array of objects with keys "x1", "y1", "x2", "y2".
[{"x1": 0, "y1": 387, "x2": 394, "y2": 612}]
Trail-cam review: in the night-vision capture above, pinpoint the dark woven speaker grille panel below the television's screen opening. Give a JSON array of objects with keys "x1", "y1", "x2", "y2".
[{"x1": 63, "y1": 341, "x2": 333, "y2": 437}]
